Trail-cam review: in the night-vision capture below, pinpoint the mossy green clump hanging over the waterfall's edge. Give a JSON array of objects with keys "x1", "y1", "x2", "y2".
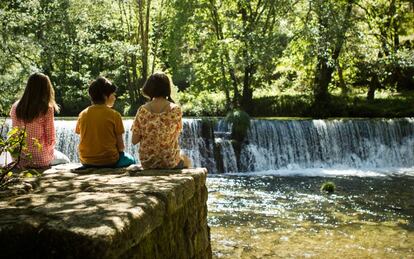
[{"x1": 225, "y1": 110, "x2": 250, "y2": 142}]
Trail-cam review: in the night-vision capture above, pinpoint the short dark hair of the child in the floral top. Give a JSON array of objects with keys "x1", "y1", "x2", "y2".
[{"x1": 142, "y1": 72, "x2": 173, "y2": 102}]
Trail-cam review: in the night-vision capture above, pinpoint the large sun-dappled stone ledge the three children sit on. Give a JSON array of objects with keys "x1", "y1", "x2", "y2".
[{"x1": 0, "y1": 164, "x2": 211, "y2": 259}]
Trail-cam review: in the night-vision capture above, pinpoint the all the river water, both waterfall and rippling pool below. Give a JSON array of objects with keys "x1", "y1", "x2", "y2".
[{"x1": 50, "y1": 118, "x2": 414, "y2": 258}]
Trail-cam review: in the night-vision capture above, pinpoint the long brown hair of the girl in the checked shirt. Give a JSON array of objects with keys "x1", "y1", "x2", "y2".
[{"x1": 16, "y1": 73, "x2": 59, "y2": 123}]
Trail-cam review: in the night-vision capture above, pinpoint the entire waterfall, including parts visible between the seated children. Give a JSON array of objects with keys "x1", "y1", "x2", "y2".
[{"x1": 37, "y1": 118, "x2": 414, "y2": 173}]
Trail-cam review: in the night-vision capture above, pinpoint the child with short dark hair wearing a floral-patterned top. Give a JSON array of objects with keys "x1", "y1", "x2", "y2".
[{"x1": 131, "y1": 72, "x2": 191, "y2": 169}]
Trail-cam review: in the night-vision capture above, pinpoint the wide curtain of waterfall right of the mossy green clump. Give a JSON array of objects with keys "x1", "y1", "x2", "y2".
[{"x1": 240, "y1": 118, "x2": 414, "y2": 171}]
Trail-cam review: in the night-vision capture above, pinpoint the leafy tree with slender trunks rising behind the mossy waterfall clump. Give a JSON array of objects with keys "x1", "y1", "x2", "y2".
[{"x1": 200, "y1": 0, "x2": 289, "y2": 112}]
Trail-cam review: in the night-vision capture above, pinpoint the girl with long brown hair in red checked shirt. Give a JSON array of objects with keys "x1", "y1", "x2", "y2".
[{"x1": 10, "y1": 73, "x2": 69, "y2": 168}]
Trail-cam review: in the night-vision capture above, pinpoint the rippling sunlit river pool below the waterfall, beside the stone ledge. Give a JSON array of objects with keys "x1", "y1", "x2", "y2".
[{"x1": 208, "y1": 170, "x2": 414, "y2": 258}]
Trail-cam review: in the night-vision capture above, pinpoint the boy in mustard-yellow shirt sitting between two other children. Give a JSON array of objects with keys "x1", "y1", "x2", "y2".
[{"x1": 76, "y1": 77, "x2": 135, "y2": 167}]
